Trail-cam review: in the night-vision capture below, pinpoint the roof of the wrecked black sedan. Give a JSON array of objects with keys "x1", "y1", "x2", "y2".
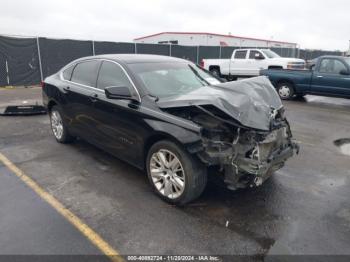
[{"x1": 72, "y1": 54, "x2": 188, "y2": 64}]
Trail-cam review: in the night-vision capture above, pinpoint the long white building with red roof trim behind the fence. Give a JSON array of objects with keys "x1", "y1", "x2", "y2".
[{"x1": 134, "y1": 32, "x2": 297, "y2": 48}]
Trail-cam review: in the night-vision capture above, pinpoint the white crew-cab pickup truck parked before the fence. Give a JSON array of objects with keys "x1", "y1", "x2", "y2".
[{"x1": 201, "y1": 49, "x2": 305, "y2": 80}]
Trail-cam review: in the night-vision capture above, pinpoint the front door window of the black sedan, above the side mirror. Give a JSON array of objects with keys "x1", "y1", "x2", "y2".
[{"x1": 97, "y1": 61, "x2": 132, "y2": 90}]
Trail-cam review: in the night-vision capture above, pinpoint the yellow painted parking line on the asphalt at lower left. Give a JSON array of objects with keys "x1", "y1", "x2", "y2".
[{"x1": 0, "y1": 153, "x2": 124, "y2": 262}]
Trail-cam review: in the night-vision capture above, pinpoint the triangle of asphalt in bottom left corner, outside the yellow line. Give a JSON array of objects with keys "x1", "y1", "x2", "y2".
[{"x1": 0, "y1": 165, "x2": 107, "y2": 256}]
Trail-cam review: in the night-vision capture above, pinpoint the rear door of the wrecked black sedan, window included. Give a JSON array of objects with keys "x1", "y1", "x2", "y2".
[{"x1": 65, "y1": 60, "x2": 101, "y2": 143}]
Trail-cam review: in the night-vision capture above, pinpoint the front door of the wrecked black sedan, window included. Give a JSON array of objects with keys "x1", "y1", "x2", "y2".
[{"x1": 90, "y1": 61, "x2": 148, "y2": 165}]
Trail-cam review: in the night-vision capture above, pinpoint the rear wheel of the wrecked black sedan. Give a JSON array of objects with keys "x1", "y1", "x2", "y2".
[{"x1": 50, "y1": 105, "x2": 75, "y2": 144}]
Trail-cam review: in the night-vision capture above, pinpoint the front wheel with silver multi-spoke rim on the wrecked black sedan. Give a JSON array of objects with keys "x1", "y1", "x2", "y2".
[{"x1": 146, "y1": 140, "x2": 207, "y2": 206}]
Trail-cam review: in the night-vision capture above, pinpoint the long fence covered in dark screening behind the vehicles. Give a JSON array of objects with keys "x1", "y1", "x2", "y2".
[{"x1": 0, "y1": 33, "x2": 342, "y2": 87}]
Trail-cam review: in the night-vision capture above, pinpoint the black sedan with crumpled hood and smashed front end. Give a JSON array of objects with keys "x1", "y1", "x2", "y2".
[{"x1": 43, "y1": 55, "x2": 297, "y2": 205}]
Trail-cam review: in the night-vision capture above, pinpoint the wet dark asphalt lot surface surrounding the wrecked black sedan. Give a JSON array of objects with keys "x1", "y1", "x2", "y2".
[{"x1": 0, "y1": 88, "x2": 350, "y2": 258}]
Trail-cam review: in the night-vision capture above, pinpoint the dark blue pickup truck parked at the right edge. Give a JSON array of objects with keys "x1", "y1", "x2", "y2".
[{"x1": 261, "y1": 56, "x2": 350, "y2": 99}]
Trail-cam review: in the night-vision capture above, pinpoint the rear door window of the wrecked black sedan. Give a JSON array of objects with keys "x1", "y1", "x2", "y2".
[{"x1": 71, "y1": 60, "x2": 100, "y2": 87}]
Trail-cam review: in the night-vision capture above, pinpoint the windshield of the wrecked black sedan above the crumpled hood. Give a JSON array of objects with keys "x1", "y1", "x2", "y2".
[{"x1": 129, "y1": 62, "x2": 220, "y2": 98}]
